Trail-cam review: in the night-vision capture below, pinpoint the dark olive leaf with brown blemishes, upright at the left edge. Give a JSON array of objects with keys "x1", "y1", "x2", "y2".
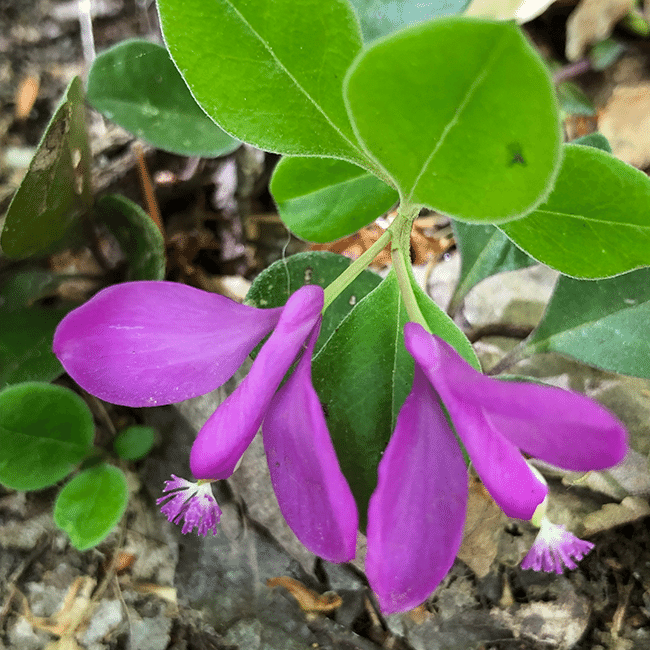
[{"x1": 0, "y1": 77, "x2": 93, "y2": 258}]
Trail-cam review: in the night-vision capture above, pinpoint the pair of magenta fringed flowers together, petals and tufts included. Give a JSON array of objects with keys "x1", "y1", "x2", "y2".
[{"x1": 54, "y1": 282, "x2": 627, "y2": 613}]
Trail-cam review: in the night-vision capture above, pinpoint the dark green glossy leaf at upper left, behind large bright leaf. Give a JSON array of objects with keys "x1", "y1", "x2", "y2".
[{"x1": 87, "y1": 40, "x2": 241, "y2": 158}]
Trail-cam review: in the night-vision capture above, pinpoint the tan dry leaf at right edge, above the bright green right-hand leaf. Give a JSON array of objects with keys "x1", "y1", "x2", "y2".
[{"x1": 598, "y1": 83, "x2": 650, "y2": 168}]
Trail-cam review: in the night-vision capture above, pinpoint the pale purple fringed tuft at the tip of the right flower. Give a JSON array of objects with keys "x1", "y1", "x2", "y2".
[{"x1": 521, "y1": 517, "x2": 594, "y2": 573}]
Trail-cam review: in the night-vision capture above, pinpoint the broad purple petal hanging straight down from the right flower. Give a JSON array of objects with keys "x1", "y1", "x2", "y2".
[{"x1": 366, "y1": 365, "x2": 467, "y2": 614}]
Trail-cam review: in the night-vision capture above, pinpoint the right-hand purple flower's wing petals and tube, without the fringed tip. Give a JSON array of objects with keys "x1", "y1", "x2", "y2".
[{"x1": 366, "y1": 323, "x2": 627, "y2": 613}]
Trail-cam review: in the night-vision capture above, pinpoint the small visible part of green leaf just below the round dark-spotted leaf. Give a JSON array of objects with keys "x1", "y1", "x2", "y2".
[{"x1": 449, "y1": 221, "x2": 537, "y2": 314}]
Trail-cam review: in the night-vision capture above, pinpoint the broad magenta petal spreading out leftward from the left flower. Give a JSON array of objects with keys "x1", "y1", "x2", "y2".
[{"x1": 53, "y1": 281, "x2": 281, "y2": 406}]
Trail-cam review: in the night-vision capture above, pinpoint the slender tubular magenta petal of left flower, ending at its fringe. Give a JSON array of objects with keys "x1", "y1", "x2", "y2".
[{"x1": 190, "y1": 285, "x2": 323, "y2": 479}]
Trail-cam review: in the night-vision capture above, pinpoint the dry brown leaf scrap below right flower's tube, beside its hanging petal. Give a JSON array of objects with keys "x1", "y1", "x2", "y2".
[{"x1": 458, "y1": 477, "x2": 507, "y2": 578}]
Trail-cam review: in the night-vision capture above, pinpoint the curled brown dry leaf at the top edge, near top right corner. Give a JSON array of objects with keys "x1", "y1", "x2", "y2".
[{"x1": 565, "y1": 0, "x2": 634, "y2": 61}]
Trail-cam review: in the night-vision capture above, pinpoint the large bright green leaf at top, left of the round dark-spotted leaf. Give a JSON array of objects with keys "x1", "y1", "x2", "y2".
[{"x1": 158, "y1": 0, "x2": 367, "y2": 164}]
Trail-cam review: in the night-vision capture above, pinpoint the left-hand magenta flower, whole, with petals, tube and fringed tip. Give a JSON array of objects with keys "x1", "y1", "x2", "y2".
[{"x1": 54, "y1": 282, "x2": 358, "y2": 562}]
